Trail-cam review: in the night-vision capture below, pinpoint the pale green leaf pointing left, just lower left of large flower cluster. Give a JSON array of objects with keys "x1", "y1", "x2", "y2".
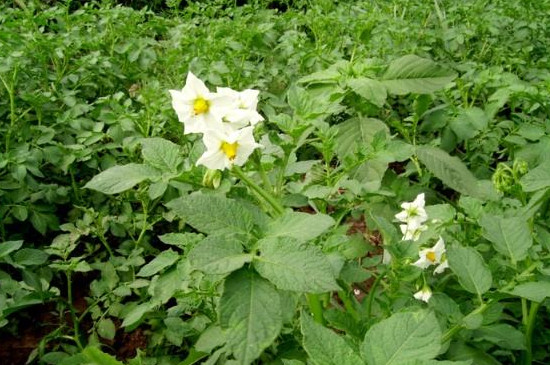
[{"x1": 84, "y1": 163, "x2": 160, "y2": 194}]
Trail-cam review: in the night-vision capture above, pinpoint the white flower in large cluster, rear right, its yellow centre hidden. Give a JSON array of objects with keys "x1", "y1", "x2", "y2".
[{"x1": 216, "y1": 87, "x2": 264, "y2": 128}]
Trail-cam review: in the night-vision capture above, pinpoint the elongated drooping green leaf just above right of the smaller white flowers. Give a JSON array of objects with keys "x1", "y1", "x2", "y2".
[{"x1": 416, "y1": 146, "x2": 480, "y2": 197}]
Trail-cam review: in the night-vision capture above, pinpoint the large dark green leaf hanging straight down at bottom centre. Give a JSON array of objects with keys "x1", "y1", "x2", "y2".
[{"x1": 219, "y1": 269, "x2": 282, "y2": 365}]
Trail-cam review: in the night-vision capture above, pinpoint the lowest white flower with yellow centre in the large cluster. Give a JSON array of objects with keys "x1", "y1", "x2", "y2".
[{"x1": 197, "y1": 127, "x2": 261, "y2": 170}]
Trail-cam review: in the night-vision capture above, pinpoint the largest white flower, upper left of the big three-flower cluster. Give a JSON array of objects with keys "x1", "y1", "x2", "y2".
[{"x1": 170, "y1": 72, "x2": 233, "y2": 134}]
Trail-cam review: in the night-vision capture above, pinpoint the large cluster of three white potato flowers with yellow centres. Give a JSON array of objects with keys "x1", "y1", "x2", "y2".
[{"x1": 170, "y1": 72, "x2": 264, "y2": 170}]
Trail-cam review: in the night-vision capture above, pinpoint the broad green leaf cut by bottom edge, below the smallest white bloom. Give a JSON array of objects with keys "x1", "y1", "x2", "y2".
[{"x1": 361, "y1": 311, "x2": 441, "y2": 365}]
